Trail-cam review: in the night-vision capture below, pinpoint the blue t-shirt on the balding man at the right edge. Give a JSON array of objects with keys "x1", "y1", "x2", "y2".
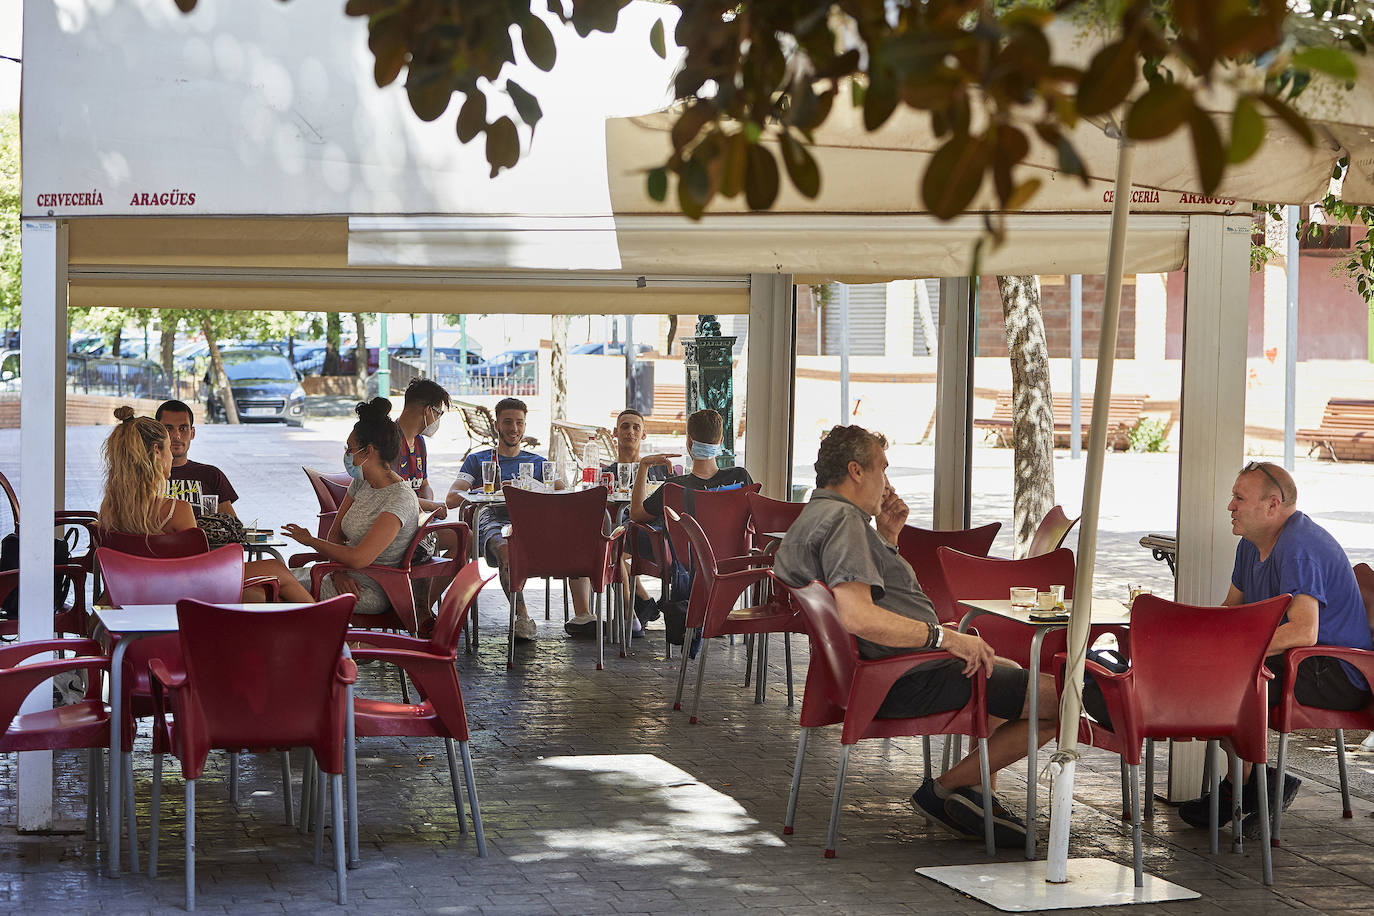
[{"x1": 1231, "y1": 512, "x2": 1374, "y2": 688}]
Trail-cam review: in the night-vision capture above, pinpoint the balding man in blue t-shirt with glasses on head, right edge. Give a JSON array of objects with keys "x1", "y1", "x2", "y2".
[{"x1": 1179, "y1": 461, "x2": 1374, "y2": 835}]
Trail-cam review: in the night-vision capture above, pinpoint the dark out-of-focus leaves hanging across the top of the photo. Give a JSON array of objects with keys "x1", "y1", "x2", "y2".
[{"x1": 166, "y1": 0, "x2": 1374, "y2": 218}]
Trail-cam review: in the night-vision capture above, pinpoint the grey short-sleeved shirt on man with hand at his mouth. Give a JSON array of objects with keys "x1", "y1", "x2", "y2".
[{"x1": 774, "y1": 489, "x2": 940, "y2": 658}]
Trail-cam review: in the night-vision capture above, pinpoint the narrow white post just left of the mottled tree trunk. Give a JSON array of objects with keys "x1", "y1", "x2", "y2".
[{"x1": 932, "y1": 277, "x2": 973, "y2": 530}]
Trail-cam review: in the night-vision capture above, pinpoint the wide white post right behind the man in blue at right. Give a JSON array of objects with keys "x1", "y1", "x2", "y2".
[{"x1": 1168, "y1": 214, "x2": 1250, "y2": 801}]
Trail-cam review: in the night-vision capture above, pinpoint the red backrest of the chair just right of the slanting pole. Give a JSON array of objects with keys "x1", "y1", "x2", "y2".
[{"x1": 1131, "y1": 595, "x2": 1292, "y2": 761}]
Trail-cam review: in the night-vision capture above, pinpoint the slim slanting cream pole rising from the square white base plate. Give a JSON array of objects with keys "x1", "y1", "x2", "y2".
[{"x1": 1031, "y1": 128, "x2": 1132, "y2": 884}]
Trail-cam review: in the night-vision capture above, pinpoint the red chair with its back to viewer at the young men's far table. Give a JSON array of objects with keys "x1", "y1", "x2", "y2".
[{"x1": 503, "y1": 485, "x2": 629, "y2": 672}]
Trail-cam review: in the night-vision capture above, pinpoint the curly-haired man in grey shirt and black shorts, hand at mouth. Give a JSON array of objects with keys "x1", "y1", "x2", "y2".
[{"x1": 774, "y1": 426, "x2": 1059, "y2": 847}]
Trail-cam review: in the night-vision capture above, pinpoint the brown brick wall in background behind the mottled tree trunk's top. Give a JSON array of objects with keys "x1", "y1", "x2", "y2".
[{"x1": 978, "y1": 276, "x2": 1135, "y2": 360}]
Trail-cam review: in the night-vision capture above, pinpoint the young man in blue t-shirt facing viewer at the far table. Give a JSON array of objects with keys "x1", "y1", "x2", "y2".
[{"x1": 447, "y1": 397, "x2": 588, "y2": 643}]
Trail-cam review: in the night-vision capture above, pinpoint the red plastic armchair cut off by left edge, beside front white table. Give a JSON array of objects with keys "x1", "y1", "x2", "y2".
[{"x1": 0, "y1": 640, "x2": 110, "y2": 838}]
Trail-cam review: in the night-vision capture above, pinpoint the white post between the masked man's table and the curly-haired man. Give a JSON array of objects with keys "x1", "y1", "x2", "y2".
[{"x1": 745, "y1": 273, "x2": 797, "y2": 500}]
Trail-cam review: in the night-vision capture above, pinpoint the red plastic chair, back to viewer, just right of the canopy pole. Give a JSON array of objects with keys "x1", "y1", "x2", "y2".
[{"x1": 1055, "y1": 595, "x2": 1293, "y2": 887}]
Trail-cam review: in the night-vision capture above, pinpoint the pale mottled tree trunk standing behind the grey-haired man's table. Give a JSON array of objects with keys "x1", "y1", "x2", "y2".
[{"x1": 998, "y1": 276, "x2": 1054, "y2": 558}]
